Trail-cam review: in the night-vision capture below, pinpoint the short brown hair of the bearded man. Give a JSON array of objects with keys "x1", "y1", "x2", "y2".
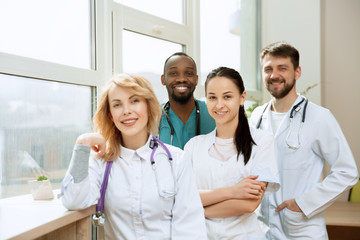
[{"x1": 260, "y1": 41, "x2": 300, "y2": 69}]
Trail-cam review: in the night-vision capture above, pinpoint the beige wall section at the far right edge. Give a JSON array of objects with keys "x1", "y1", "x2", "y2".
[{"x1": 321, "y1": 0, "x2": 360, "y2": 176}]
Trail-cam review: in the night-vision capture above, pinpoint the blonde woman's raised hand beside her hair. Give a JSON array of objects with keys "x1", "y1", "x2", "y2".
[{"x1": 76, "y1": 133, "x2": 106, "y2": 158}]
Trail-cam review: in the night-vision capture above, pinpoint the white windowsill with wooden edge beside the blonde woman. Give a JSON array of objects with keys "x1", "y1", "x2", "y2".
[{"x1": 0, "y1": 190, "x2": 95, "y2": 240}]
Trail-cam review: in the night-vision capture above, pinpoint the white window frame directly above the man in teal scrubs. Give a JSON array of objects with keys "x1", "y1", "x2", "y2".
[{"x1": 112, "y1": 0, "x2": 203, "y2": 94}]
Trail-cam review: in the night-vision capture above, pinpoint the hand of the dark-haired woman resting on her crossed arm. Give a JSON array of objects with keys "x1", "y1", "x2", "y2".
[{"x1": 232, "y1": 175, "x2": 265, "y2": 199}]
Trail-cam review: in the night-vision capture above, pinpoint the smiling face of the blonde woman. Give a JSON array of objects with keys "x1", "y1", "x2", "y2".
[{"x1": 108, "y1": 86, "x2": 148, "y2": 147}]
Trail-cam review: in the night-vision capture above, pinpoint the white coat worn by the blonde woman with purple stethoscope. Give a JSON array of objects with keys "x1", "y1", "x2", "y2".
[{"x1": 62, "y1": 136, "x2": 206, "y2": 240}]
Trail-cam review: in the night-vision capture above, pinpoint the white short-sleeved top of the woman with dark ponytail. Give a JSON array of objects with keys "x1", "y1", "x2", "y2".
[{"x1": 184, "y1": 129, "x2": 280, "y2": 240}]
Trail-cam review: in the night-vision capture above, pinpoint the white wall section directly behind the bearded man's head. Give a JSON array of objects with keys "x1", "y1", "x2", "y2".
[{"x1": 262, "y1": 0, "x2": 321, "y2": 104}]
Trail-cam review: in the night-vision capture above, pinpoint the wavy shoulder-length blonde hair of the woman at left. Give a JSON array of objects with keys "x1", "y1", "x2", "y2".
[{"x1": 93, "y1": 73, "x2": 161, "y2": 161}]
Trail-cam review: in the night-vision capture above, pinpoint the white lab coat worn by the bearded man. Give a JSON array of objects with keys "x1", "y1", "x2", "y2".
[{"x1": 250, "y1": 96, "x2": 359, "y2": 240}]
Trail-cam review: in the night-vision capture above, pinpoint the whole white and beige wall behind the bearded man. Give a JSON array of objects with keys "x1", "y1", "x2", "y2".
[{"x1": 261, "y1": 0, "x2": 360, "y2": 197}]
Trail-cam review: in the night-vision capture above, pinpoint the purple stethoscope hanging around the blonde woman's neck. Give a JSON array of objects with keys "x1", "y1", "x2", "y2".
[{"x1": 92, "y1": 136, "x2": 178, "y2": 226}]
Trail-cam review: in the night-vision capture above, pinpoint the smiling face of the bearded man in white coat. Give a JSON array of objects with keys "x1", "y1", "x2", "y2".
[{"x1": 261, "y1": 54, "x2": 301, "y2": 99}]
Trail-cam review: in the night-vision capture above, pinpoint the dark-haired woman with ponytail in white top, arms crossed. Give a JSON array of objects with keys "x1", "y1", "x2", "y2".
[{"x1": 185, "y1": 67, "x2": 279, "y2": 239}]
